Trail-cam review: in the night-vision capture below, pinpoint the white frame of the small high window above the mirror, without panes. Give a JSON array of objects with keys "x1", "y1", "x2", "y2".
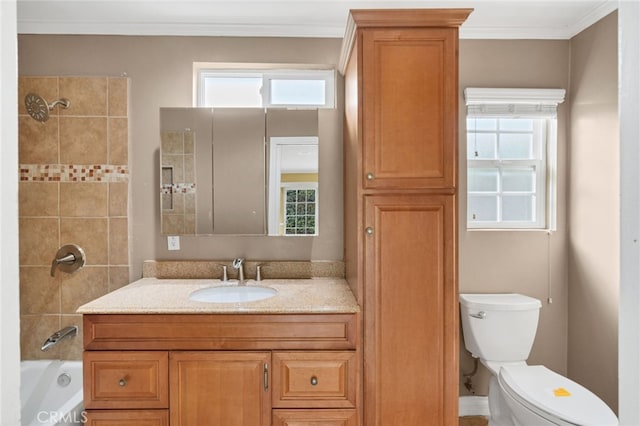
[{"x1": 194, "y1": 62, "x2": 336, "y2": 109}]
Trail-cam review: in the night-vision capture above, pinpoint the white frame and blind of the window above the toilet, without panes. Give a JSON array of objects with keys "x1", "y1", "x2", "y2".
[{"x1": 464, "y1": 88, "x2": 565, "y2": 230}]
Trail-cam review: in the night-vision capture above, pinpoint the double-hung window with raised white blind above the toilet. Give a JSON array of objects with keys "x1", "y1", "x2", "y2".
[{"x1": 465, "y1": 88, "x2": 564, "y2": 229}]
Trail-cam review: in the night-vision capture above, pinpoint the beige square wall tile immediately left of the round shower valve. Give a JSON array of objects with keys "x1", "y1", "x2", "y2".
[{"x1": 18, "y1": 218, "x2": 59, "y2": 266}]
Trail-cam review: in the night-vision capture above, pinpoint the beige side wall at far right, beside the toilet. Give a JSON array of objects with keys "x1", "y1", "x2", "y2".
[{"x1": 568, "y1": 13, "x2": 620, "y2": 410}]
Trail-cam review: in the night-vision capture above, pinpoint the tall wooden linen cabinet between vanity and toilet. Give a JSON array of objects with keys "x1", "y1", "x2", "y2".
[{"x1": 341, "y1": 9, "x2": 471, "y2": 426}]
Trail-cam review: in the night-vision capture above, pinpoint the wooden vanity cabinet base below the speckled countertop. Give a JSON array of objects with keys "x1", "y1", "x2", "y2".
[{"x1": 83, "y1": 314, "x2": 359, "y2": 426}]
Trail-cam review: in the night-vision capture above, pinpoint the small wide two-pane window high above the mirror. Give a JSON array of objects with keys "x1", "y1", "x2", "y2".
[{"x1": 195, "y1": 63, "x2": 335, "y2": 108}]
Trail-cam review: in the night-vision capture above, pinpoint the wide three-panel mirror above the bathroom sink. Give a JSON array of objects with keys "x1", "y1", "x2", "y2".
[{"x1": 160, "y1": 108, "x2": 318, "y2": 235}]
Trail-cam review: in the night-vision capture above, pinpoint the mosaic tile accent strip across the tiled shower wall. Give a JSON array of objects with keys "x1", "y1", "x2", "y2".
[{"x1": 19, "y1": 164, "x2": 129, "y2": 182}]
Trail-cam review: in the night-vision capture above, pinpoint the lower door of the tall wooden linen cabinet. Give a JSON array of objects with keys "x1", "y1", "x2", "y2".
[{"x1": 364, "y1": 195, "x2": 458, "y2": 426}]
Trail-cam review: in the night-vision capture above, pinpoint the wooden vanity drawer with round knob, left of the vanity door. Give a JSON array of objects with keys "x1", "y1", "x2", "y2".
[{"x1": 83, "y1": 351, "x2": 169, "y2": 409}]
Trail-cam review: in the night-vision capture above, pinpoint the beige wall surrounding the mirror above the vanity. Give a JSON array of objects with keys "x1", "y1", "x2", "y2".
[{"x1": 18, "y1": 35, "x2": 342, "y2": 279}]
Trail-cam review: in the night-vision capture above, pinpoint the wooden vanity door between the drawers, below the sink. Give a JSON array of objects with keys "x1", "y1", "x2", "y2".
[{"x1": 169, "y1": 351, "x2": 271, "y2": 426}]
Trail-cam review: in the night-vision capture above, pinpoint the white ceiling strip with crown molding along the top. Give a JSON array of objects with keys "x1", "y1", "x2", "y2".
[{"x1": 17, "y1": 0, "x2": 618, "y2": 39}]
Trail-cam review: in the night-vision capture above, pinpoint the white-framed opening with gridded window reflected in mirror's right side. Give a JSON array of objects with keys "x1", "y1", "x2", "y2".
[{"x1": 269, "y1": 137, "x2": 318, "y2": 235}]
